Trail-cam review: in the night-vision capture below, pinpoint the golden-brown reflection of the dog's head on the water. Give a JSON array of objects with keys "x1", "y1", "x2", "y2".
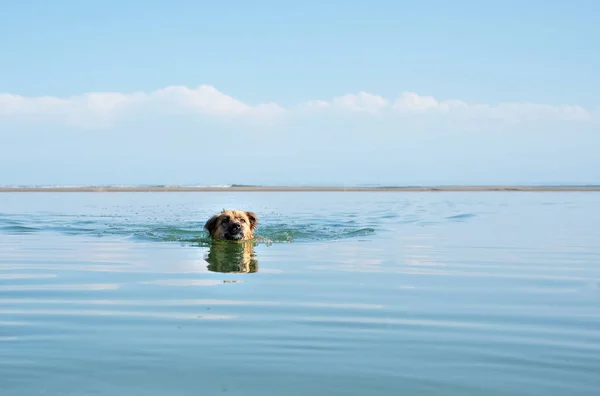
[{"x1": 205, "y1": 241, "x2": 258, "y2": 274}]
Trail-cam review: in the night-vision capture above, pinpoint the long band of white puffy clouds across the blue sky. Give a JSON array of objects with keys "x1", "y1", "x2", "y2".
[{"x1": 0, "y1": 85, "x2": 599, "y2": 126}]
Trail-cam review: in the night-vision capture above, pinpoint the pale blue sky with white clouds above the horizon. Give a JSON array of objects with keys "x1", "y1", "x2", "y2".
[{"x1": 0, "y1": 0, "x2": 600, "y2": 185}]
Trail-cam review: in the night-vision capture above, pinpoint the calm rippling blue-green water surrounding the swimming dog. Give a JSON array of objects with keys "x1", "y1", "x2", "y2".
[{"x1": 0, "y1": 192, "x2": 600, "y2": 396}]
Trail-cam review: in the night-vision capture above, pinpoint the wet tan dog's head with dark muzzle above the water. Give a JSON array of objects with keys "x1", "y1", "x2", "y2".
[{"x1": 204, "y1": 210, "x2": 258, "y2": 241}]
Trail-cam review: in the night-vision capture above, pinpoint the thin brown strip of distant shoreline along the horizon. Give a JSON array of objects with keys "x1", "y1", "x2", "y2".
[{"x1": 0, "y1": 186, "x2": 600, "y2": 193}]
